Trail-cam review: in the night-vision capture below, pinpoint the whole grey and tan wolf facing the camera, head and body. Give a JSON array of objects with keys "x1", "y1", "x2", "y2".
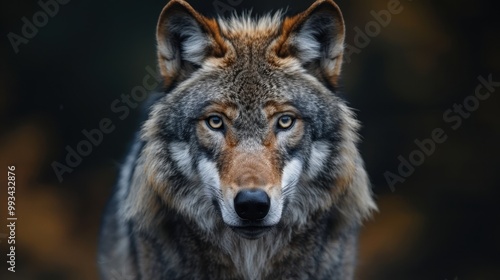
[{"x1": 99, "y1": 0, "x2": 376, "y2": 280}]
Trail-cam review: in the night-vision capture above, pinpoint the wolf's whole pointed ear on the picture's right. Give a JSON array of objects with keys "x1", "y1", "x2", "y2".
[{"x1": 276, "y1": 0, "x2": 345, "y2": 87}]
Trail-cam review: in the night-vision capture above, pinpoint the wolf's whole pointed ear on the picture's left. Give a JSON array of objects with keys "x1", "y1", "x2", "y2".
[{"x1": 156, "y1": 0, "x2": 227, "y2": 87}]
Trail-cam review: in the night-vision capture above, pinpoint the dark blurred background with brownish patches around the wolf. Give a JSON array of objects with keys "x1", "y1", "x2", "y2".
[{"x1": 0, "y1": 0, "x2": 500, "y2": 280}]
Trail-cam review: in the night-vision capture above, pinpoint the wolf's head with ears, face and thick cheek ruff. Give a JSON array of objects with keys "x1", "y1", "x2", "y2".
[{"x1": 126, "y1": 0, "x2": 375, "y2": 239}]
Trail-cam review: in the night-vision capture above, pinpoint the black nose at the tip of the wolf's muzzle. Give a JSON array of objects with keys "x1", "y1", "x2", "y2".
[{"x1": 234, "y1": 189, "x2": 271, "y2": 221}]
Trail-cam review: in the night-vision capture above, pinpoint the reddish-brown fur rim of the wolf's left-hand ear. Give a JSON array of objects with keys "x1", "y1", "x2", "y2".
[{"x1": 156, "y1": 0, "x2": 227, "y2": 87}]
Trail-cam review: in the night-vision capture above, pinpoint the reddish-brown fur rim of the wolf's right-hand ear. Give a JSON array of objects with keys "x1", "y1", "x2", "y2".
[{"x1": 274, "y1": 0, "x2": 345, "y2": 85}]
